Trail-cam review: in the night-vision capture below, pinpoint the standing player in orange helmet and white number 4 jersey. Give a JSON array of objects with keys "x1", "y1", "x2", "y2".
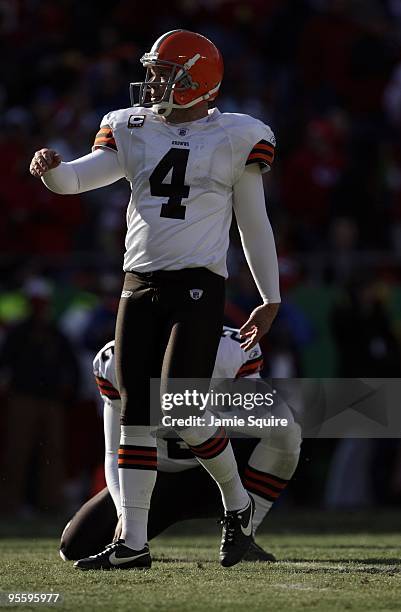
[{"x1": 30, "y1": 30, "x2": 280, "y2": 569}]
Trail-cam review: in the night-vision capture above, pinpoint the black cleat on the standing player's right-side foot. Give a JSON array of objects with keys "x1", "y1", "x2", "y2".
[{"x1": 220, "y1": 497, "x2": 255, "y2": 567}]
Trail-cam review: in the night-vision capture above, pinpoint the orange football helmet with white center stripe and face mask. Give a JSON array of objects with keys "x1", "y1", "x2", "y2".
[{"x1": 130, "y1": 30, "x2": 224, "y2": 117}]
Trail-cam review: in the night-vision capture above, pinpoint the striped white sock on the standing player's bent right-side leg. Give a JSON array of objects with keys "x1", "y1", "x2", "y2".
[{"x1": 178, "y1": 414, "x2": 249, "y2": 510}]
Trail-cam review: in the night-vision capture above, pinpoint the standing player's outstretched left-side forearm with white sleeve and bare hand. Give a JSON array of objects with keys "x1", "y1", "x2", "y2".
[{"x1": 29, "y1": 148, "x2": 124, "y2": 194}]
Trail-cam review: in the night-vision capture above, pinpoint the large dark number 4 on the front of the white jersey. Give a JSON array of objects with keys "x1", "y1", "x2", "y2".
[{"x1": 149, "y1": 149, "x2": 190, "y2": 219}]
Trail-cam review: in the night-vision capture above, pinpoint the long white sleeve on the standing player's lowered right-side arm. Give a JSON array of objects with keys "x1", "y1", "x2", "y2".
[{"x1": 234, "y1": 164, "x2": 281, "y2": 303}]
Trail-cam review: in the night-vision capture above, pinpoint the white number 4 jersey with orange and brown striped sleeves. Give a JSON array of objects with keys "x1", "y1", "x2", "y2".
[{"x1": 93, "y1": 108, "x2": 275, "y2": 277}]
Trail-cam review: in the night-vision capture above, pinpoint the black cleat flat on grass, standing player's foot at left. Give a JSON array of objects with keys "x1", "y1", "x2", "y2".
[{"x1": 74, "y1": 540, "x2": 152, "y2": 570}]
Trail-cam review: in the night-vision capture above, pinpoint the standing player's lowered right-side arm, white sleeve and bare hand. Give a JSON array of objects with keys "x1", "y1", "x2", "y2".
[{"x1": 234, "y1": 164, "x2": 281, "y2": 350}]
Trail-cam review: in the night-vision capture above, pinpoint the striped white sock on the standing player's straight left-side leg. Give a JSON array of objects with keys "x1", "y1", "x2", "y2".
[{"x1": 119, "y1": 425, "x2": 157, "y2": 550}]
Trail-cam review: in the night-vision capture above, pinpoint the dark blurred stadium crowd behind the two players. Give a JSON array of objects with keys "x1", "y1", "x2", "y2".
[{"x1": 0, "y1": 0, "x2": 401, "y2": 521}]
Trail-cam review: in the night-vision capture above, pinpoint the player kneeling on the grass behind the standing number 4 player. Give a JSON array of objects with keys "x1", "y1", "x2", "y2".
[{"x1": 60, "y1": 326, "x2": 301, "y2": 561}]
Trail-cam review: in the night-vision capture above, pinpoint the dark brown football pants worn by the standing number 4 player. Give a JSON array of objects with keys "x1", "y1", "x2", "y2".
[{"x1": 115, "y1": 268, "x2": 225, "y2": 426}]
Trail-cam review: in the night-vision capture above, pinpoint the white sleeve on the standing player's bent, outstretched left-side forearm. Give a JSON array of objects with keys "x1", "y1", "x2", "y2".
[{"x1": 42, "y1": 149, "x2": 125, "y2": 194}]
